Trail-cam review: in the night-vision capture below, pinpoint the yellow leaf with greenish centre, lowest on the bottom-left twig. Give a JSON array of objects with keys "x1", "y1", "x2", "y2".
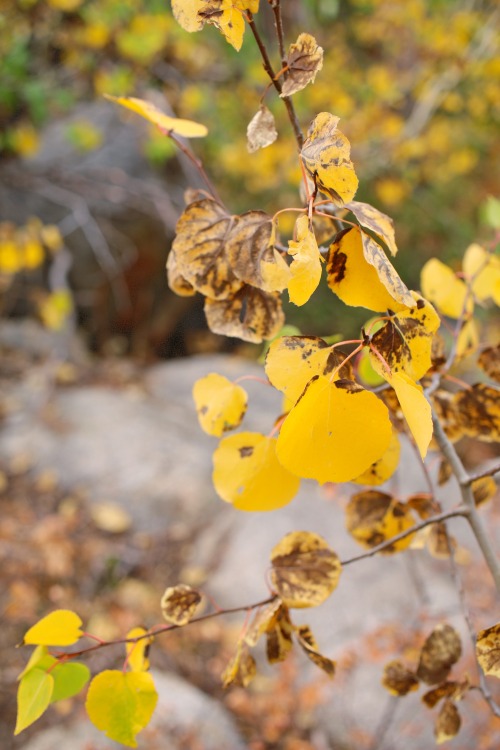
[{"x1": 85, "y1": 669, "x2": 158, "y2": 747}]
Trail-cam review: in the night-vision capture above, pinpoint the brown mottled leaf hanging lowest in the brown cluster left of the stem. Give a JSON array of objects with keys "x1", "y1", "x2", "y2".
[{"x1": 205, "y1": 284, "x2": 285, "y2": 344}]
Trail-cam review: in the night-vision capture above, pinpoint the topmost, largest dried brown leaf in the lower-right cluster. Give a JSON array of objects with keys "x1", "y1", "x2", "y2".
[{"x1": 417, "y1": 624, "x2": 462, "y2": 685}]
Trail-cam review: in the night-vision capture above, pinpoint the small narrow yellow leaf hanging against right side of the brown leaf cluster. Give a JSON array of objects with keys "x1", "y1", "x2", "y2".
[{"x1": 288, "y1": 216, "x2": 322, "y2": 305}]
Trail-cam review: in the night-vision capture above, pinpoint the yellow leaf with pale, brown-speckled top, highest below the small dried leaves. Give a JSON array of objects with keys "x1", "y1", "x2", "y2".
[{"x1": 300, "y1": 112, "x2": 358, "y2": 206}]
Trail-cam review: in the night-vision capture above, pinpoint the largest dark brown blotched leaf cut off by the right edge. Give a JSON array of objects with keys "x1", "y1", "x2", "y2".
[{"x1": 452, "y1": 383, "x2": 500, "y2": 442}]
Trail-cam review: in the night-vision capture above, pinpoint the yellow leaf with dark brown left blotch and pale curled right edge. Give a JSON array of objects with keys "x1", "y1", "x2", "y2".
[{"x1": 327, "y1": 227, "x2": 416, "y2": 312}]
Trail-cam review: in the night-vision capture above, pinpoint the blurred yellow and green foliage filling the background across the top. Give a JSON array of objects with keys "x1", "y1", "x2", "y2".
[{"x1": 0, "y1": 0, "x2": 500, "y2": 352}]
